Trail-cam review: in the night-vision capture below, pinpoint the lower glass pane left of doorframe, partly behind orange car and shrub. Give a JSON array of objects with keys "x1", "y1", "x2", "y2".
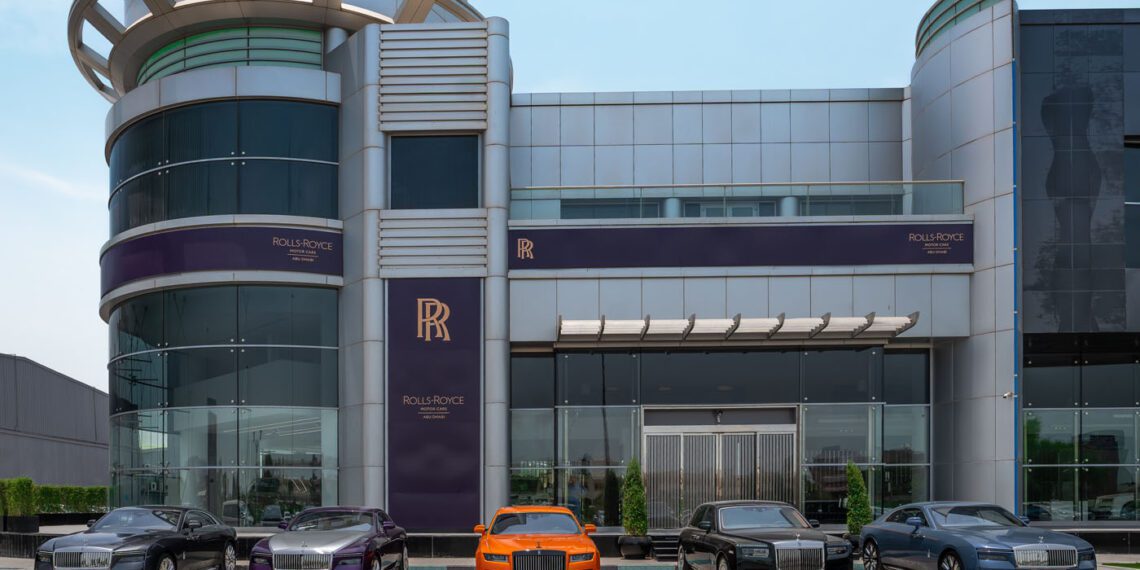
[{"x1": 557, "y1": 469, "x2": 625, "y2": 527}]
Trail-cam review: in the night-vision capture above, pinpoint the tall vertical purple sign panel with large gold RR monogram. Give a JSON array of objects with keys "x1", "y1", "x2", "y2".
[{"x1": 387, "y1": 278, "x2": 483, "y2": 531}]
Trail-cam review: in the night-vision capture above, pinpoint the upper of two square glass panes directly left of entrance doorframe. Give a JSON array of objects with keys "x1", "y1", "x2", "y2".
[{"x1": 559, "y1": 406, "x2": 641, "y2": 466}]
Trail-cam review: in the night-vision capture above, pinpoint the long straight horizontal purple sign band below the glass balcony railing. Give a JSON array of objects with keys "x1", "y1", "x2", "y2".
[{"x1": 510, "y1": 222, "x2": 974, "y2": 269}]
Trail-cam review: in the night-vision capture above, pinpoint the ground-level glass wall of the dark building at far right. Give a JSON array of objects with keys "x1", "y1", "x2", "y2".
[{"x1": 1021, "y1": 334, "x2": 1140, "y2": 522}]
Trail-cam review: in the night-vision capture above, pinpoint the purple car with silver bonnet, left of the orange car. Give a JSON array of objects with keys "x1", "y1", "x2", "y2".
[{"x1": 250, "y1": 506, "x2": 408, "y2": 570}]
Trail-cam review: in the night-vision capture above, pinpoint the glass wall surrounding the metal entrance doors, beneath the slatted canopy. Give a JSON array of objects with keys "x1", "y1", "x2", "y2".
[{"x1": 511, "y1": 348, "x2": 930, "y2": 526}]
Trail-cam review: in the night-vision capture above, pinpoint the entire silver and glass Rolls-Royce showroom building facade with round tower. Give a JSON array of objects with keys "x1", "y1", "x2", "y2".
[{"x1": 70, "y1": 0, "x2": 1140, "y2": 531}]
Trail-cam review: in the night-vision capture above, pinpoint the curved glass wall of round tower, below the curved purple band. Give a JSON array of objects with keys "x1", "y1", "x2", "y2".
[{"x1": 108, "y1": 285, "x2": 337, "y2": 527}]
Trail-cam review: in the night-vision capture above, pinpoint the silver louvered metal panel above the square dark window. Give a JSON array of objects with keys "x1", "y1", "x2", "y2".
[{"x1": 380, "y1": 22, "x2": 488, "y2": 131}]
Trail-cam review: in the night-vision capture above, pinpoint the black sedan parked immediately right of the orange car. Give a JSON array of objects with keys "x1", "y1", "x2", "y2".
[{"x1": 677, "y1": 500, "x2": 852, "y2": 570}]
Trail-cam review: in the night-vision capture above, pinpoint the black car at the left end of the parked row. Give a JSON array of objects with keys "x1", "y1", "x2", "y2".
[{"x1": 35, "y1": 506, "x2": 237, "y2": 570}]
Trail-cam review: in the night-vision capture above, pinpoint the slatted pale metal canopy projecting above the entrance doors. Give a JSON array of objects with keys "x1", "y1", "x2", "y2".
[{"x1": 557, "y1": 311, "x2": 919, "y2": 343}]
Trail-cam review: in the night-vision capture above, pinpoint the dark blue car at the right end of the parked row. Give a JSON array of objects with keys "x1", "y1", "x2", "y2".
[{"x1": 862, "y1": 503, "x2": 1097, "y2": 570}]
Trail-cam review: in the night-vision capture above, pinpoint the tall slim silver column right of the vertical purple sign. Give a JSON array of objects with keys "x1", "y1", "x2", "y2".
[{"x1": 483, "y1": 18, "x2": 511, "y2": 521}]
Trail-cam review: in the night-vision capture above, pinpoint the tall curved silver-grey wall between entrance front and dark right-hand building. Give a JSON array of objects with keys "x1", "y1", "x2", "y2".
[{"x1": 910, "y1": 0, "x2": 1016, "y2": 508}]
